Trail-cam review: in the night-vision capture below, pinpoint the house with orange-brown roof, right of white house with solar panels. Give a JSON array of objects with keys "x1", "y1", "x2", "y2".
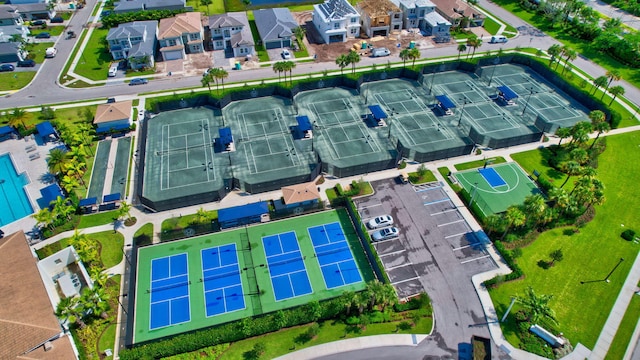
[{"x1": 356, "y1": 0, "x2": 402, "y2": 37}]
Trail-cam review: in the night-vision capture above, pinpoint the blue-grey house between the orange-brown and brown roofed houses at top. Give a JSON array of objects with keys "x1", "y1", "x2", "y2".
[{"x1": 392, "y1": 0, "x2": 451, "y2": 42}]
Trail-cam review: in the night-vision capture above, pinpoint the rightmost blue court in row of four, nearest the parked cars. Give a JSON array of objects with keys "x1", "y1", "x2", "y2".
[{"x1": 308, "y1": 222, "x2": 362, "y2": 289}]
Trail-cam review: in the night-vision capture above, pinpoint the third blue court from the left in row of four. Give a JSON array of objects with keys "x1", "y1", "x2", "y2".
[{"x1": 262, "y1": 231, "x2": 313, "y2": 301}]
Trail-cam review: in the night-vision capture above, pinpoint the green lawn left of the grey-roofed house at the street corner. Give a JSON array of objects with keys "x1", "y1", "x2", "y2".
[{"x1": 75, "y1": 28, "x2": 113, "y2": 80}]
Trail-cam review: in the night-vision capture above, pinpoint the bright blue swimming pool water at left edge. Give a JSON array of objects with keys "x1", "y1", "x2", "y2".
[{"x1": 0, "y1": 154, "x2": 33, "y2": 226}]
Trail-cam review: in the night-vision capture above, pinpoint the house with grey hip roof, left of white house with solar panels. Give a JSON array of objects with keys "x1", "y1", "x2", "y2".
[{"x1": 253, "y1": 8, "x2": 299, "y2": 49}]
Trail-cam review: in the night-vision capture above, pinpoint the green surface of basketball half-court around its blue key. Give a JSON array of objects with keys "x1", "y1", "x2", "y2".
[{"x1": 453, "y1": 162, "x2": 540, "y2": 216}]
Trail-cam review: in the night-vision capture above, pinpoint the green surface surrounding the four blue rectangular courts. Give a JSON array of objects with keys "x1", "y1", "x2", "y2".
[{"x1": 133, "y1": 210, "x2": 374, "y2": 343}]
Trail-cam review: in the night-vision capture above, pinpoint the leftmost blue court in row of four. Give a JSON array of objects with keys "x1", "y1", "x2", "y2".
[{"x1": 149, "y1": 253, "x2": 191, "y2": 330}]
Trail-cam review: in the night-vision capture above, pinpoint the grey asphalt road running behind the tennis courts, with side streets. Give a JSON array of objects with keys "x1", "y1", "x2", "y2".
[{"x1": 0, "y1": 0, "x2": 640, "y2": 109}]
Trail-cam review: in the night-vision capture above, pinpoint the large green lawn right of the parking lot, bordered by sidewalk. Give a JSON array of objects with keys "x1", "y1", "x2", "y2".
[{"x1": 490, "y1": 133, "x2": 640, "y2": 348}]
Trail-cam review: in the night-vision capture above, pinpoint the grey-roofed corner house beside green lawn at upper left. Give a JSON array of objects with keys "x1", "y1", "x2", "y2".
[{"x1": 107, "y1": 20, "x2": 158, "y2": 69}]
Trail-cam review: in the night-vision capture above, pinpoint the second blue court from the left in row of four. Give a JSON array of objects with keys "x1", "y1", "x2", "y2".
[{"x1": 200, "y1": 244, "x2": 245, "y2": 316}]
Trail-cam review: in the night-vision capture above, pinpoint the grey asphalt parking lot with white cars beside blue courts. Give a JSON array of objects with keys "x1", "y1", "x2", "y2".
[{"x1": 355, "y1": 179, "x2": 497, "y2": 348}]
